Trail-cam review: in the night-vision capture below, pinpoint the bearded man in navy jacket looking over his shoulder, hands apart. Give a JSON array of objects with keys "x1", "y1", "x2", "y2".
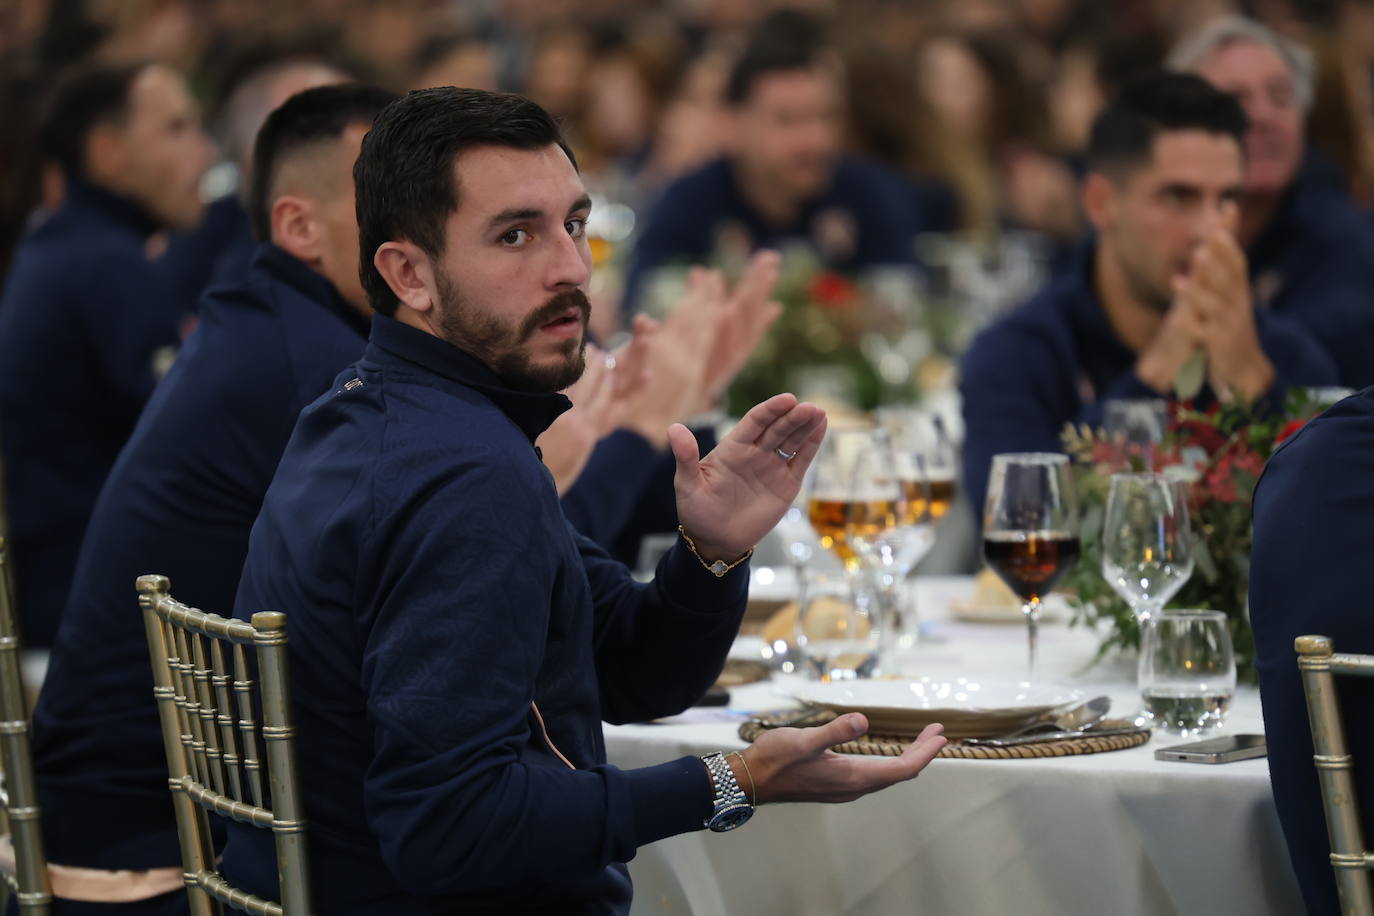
[{"x1": 224, "y1": 88, "x2": 944, "y2": 916}]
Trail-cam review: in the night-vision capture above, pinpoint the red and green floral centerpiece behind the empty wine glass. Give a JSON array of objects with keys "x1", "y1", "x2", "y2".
[{"x1": 1062, "y1": 390, "x2": 1327, "y2": 676}]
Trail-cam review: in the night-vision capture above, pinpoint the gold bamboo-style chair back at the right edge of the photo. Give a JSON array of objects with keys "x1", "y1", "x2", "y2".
[{"x1": 1294, "y1": 636, "x2": 1374, "y2": 916}]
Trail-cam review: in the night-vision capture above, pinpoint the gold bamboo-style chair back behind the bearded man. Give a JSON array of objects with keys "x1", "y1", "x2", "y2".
[{"x1": 137, "y1": 575, "x2": 311, "y2": 916}]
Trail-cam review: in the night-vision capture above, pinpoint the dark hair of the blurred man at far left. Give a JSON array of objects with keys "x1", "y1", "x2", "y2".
[{"x1": 38, "y1": 63, "x2": 148, "y2": 177}]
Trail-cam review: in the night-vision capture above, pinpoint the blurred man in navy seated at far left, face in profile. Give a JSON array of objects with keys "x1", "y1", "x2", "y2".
[{"x1": 0, "y1": 65, "x2": 210, "y2": 645}]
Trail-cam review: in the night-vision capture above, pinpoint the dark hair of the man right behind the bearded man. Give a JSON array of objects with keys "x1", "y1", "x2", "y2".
[{"x1": 249, "y1": 82, "x2": 397, "y2": 242}]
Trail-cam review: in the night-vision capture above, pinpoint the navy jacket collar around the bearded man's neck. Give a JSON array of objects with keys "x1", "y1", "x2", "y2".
[{"x1": 368, "y1": 314, "x2": 573, "y2": 442}]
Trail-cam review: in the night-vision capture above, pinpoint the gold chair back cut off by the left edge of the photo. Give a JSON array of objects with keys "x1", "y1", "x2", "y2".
[{"x1": 0, "y1": 537, "x2": 52, "y2": 913}]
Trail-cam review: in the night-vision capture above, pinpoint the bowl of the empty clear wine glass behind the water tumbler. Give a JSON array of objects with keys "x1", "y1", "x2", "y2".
[{"x1": 1102, "y1": 474, "x2": 1193, "y2": 626}]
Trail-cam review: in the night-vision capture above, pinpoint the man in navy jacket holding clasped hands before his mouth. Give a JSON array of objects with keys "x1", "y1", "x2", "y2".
[{"x1": 960, "y1": 73, "x2": 1336, "y2": 507}]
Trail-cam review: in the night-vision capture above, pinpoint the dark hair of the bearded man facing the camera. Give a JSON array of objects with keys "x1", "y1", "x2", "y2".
[{"x1": 353, "y1": 87, "x2": 577, "y2": 314}]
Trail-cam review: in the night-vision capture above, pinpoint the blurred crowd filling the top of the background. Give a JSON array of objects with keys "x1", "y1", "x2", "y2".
[{"x1": 8, "y1": 0, "x2": 1374, "y2": 335}]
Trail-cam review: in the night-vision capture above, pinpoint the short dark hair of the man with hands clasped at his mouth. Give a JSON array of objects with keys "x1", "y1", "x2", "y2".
[{"x1": 1088, "y1": 71, "x2": 1249, "y2": 176}]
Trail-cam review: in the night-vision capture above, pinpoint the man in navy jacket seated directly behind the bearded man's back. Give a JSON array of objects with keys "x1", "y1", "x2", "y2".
[{"x1": 34, "y1": 85, "x2": 394, "y2": 913}]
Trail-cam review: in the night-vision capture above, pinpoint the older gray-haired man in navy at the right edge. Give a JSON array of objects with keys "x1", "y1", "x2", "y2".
[{"x1": 1168, "y1": 15, "x2": 1374, "y2": 389}]
